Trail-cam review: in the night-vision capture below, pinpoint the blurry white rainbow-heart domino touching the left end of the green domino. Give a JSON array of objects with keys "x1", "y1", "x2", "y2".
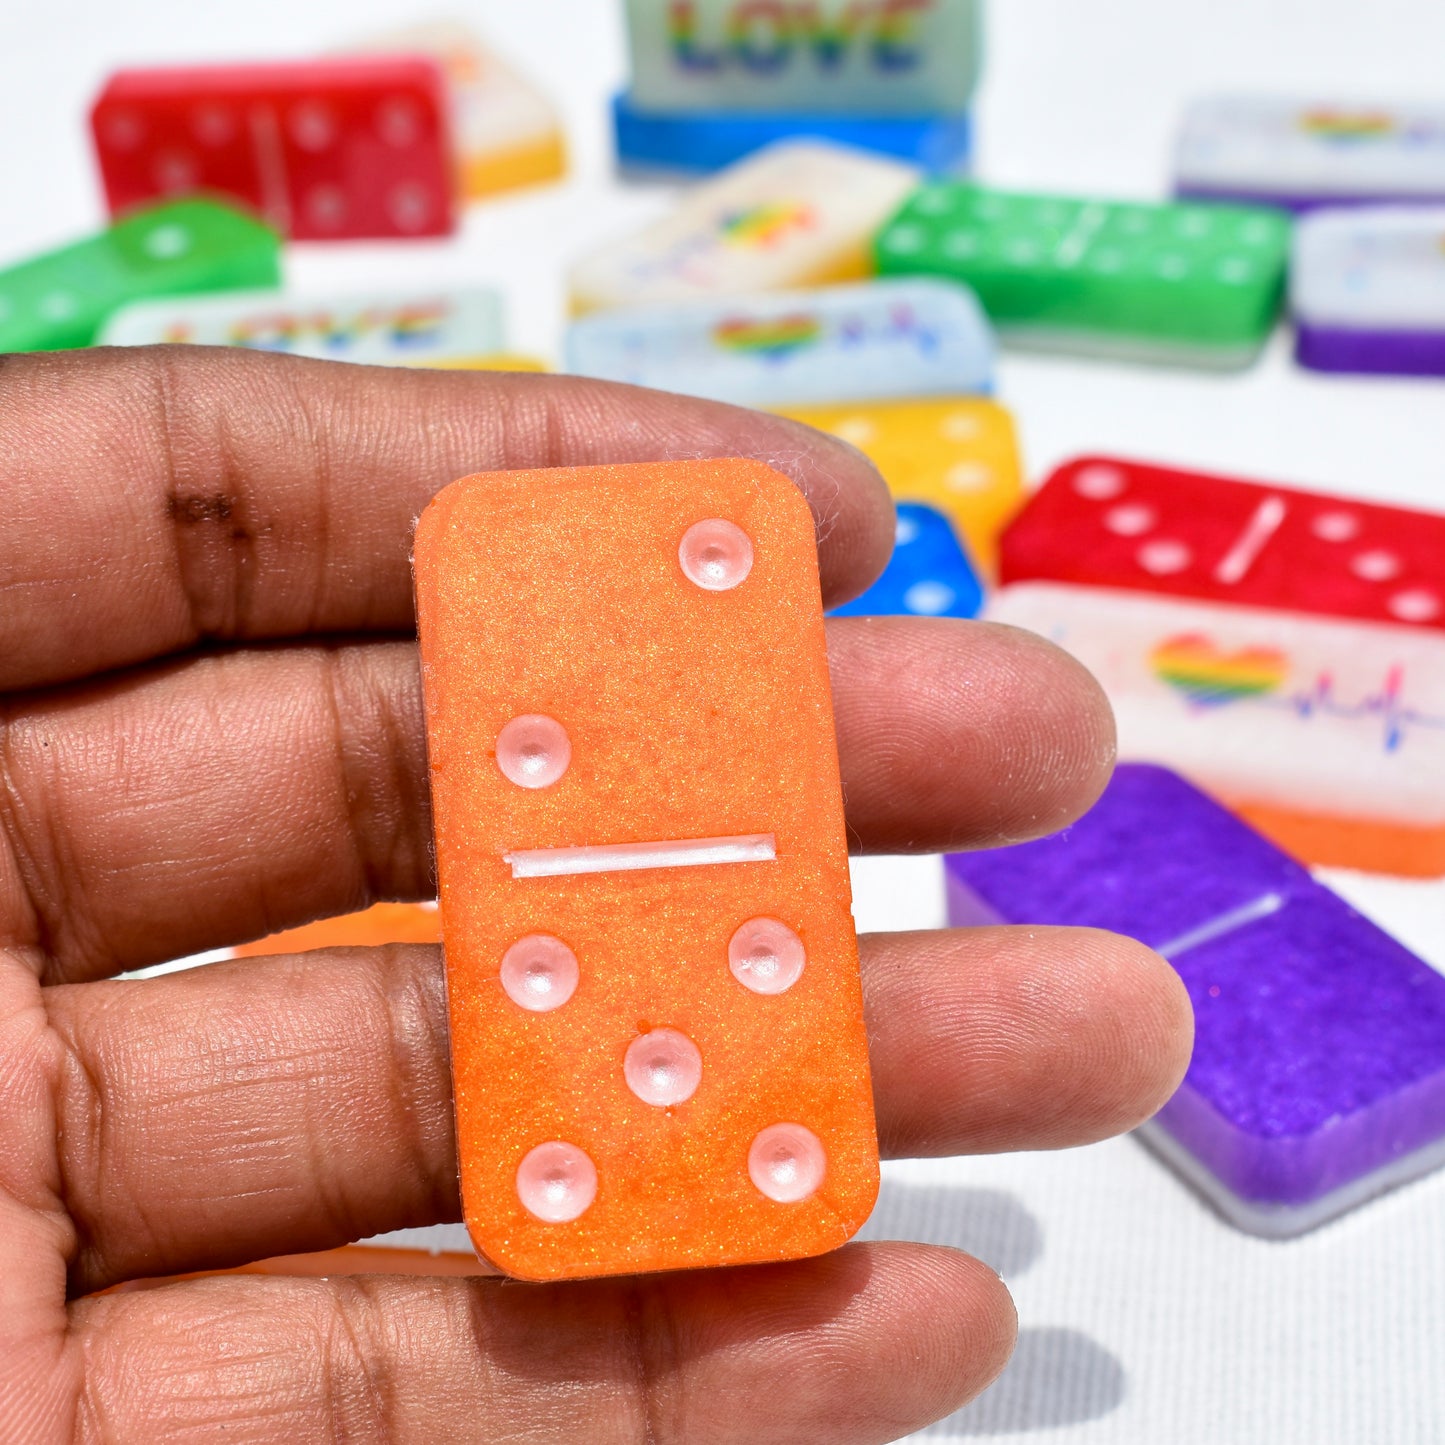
[{"x1": 569, "y1": 140, "x2": 918, "y2": 314}]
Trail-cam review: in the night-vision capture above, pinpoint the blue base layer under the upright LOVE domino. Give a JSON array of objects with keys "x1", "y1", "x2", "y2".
[{"x1": 613, "y1": 91, "x2": 972, "y2": 175}]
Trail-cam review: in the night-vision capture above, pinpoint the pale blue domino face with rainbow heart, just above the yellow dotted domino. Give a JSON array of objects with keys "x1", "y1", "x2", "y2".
[{"x1": 566, "y1": 280, "x2": 994, "y2": 407}]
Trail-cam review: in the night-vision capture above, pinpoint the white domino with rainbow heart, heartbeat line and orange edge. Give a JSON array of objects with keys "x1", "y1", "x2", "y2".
[{"x1": 984, "y1": 582, "x2": 1445, "y2": 877}]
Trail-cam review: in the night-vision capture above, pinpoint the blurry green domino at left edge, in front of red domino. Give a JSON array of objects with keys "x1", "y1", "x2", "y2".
[{"x1": 0, "y1": 199, "x2": 280, "y2": 351}]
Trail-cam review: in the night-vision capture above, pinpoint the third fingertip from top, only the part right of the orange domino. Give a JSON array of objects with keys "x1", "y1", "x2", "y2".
[{"x1": 863, "y1": 928, "x2": 1194, "y2": 1157}]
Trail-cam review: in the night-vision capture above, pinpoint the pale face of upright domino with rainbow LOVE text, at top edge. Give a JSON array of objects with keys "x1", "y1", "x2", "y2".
[{"x1": 627, "y1": 0, "x2": 981, "y2": 117}]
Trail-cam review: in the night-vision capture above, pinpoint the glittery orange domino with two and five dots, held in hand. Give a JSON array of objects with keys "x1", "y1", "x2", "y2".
[{"x1": 416, "y1": 460, "x2": 879, "y2": 1280}]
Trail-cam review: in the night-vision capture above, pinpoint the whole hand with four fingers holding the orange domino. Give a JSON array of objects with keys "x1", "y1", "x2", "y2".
[{"x1": 0, "y1": 348, "x2": 1191, "y2": 1445}]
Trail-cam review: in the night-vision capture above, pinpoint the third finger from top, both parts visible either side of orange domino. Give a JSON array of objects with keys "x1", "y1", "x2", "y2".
[{"x1": 48, "y1": 929, "x2": 1189, "y2": 1293}]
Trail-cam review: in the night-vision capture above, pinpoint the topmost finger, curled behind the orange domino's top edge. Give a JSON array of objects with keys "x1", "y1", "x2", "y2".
[{"x1": 0, "y1": 347, "x2": 893, "y2": 689}]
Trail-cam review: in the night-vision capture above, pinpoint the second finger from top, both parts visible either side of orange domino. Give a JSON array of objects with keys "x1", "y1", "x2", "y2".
[{"x1": 0, "y1": 618, "x2": 1113, "y2": 981}]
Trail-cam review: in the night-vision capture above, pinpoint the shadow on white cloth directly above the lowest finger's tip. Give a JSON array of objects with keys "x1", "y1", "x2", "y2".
[{"x1": 858, "y1": 1179, "x2": 1043, "y2": 1279}]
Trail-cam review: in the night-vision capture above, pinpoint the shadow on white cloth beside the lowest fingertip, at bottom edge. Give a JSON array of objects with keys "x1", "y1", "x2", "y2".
[{"x1": 922, "y1": 1329, "x2": 1127, "y2": 1441}]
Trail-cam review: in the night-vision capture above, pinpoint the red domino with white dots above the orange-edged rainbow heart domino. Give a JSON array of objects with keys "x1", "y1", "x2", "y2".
[{"x1": 998, "y1": 457, "x2": 1445, "y2": 630}]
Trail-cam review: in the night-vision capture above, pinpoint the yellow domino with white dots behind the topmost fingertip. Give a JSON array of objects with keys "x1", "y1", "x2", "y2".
[{"x1": 782, "y1": 396, "x2": 1023, "y2": 579}]
